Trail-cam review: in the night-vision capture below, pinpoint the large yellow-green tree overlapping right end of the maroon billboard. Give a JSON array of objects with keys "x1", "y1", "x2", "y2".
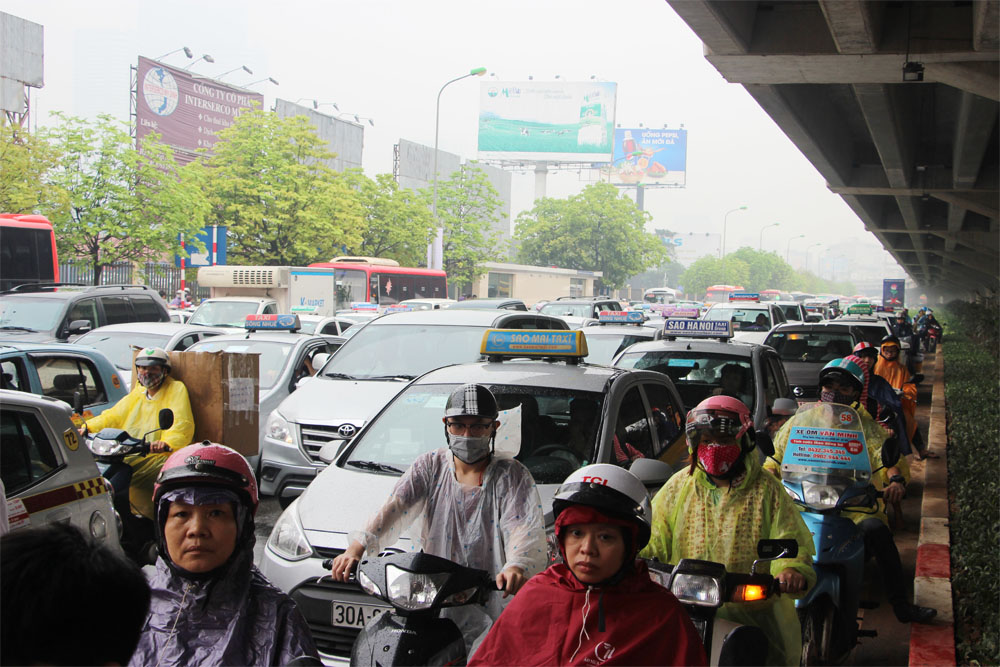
[{"x1": 199, "y1": 110, "x2": 365, "y2": 266}]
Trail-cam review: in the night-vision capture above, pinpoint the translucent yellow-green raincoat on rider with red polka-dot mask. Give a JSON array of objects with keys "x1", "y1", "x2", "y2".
[{"x1": 641, "y1": 452, "x2": 816, "y2": 665}]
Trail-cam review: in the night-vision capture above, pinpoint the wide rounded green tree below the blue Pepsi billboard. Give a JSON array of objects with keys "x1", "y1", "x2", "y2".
[{"x1": 515, "y1": 183, "x2": 668, "y2": 289}]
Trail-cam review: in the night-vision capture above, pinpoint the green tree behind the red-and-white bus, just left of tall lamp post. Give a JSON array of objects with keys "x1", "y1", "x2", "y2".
[{"x1": 343, "y1": 169, "x2": 434, "y2": 266}]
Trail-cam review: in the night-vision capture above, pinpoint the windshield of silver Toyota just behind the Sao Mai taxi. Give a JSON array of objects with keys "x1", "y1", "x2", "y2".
[{"x1": 320, "y1": 324, "x2": 486, "y2": 380}]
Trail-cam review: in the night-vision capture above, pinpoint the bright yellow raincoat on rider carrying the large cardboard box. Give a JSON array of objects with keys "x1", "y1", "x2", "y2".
[{"x1": 87, "y1": 376, "x2": 194, "y2": 519}]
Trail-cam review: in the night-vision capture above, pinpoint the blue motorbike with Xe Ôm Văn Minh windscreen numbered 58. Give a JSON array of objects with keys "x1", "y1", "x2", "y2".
[{"x1": 781, "y1": 403, "x2": 898, "y2": 665}]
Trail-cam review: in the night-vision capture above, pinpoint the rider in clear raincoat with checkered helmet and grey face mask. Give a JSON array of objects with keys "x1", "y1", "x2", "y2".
[{"x1": 331, "y1": 384, "x2": 546, "y2": 653}]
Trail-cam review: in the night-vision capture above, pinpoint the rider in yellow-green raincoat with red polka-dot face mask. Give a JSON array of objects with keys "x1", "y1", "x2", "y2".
[{"x1": 642, "y1": 396, "x2": 816, "y2": 665}]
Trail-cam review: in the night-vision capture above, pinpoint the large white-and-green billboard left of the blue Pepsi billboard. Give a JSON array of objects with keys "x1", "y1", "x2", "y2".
[{"x1": 479, "y1": 81, "x2": 618, "y2": 162}]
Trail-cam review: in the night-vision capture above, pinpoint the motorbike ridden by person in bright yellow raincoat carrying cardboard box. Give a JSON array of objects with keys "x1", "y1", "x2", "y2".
[{"x1": 77, "y1": 394, "x2": 174, "y2": 566}]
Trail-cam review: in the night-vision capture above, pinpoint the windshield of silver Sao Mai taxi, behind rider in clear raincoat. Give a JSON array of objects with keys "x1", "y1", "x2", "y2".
[{"x1": 345, "y1": 384, "x2": 604, "y2": 484}]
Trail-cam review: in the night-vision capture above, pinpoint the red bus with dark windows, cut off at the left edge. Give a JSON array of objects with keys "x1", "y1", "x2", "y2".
[{"x1": 0, "y1": 213, "x2": 59, "y2": 291}]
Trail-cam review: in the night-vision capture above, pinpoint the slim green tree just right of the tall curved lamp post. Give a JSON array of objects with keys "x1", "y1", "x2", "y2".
[{"x1": 425, "y1": 165, "x2": 505, "y2": 290}]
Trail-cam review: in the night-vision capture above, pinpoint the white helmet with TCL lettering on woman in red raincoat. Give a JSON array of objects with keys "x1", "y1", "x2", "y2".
[{"x1": 552, "y1": 463, "x2": 653, "y2": 551}]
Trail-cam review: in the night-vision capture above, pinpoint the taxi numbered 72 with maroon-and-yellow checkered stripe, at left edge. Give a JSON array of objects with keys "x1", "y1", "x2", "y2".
[{"x1": 0, "y1": 389, "x2": 121, "y2": 552}]
